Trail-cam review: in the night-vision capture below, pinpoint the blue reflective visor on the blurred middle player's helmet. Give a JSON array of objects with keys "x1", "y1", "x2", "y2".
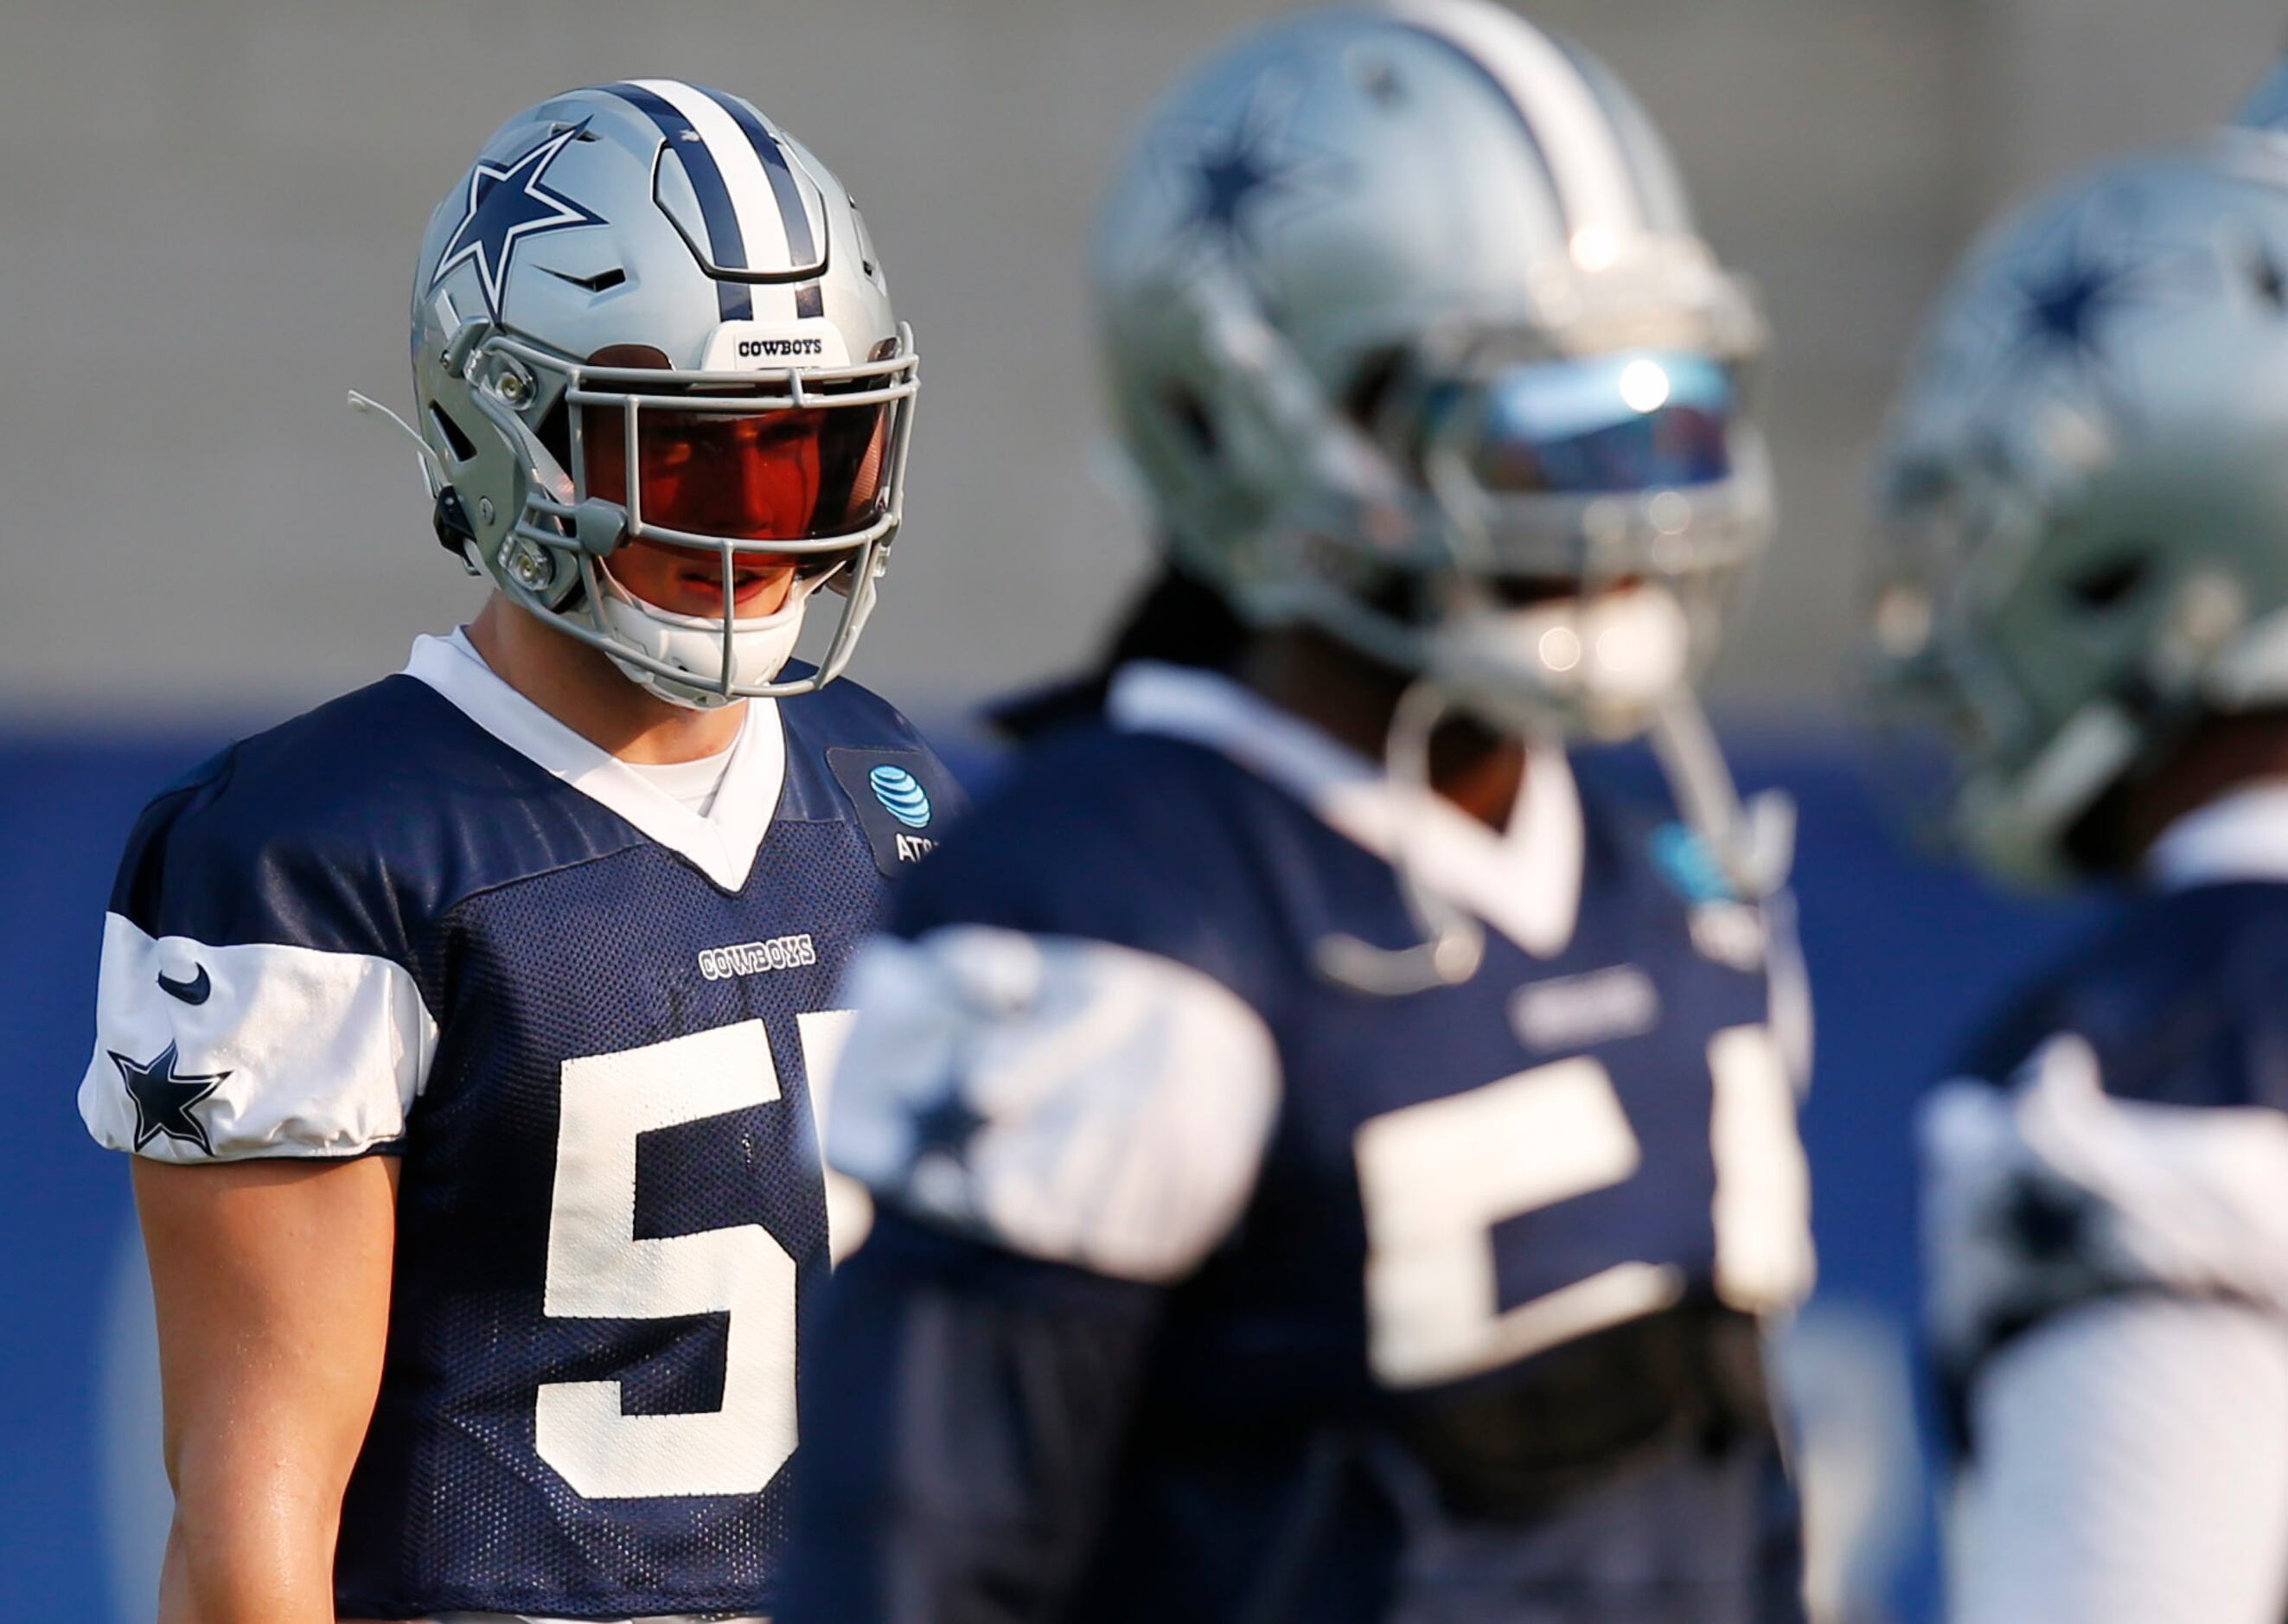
[{"x1": 1462, "y1": 352, "x2": 1736, "y2": 496}]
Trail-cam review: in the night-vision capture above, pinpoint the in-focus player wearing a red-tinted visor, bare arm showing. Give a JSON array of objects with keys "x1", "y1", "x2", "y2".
[{"x1": 80, "y1": 80, "x2": 952, "y2": 1624}]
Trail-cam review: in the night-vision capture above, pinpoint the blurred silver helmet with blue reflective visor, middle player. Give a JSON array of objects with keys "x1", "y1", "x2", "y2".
[{"x1": 1096, "y1": 0, "x2": 1771, "y2": 750}]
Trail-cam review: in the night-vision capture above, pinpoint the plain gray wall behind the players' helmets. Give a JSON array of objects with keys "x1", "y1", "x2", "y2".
[{"x1": 0, "y1": 0, "x2": 2288, "y2": 725}]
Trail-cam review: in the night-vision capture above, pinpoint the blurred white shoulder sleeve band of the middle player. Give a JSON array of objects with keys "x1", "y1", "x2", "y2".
[{"x1": 826, "y1": 926, "x2": 1279, "y2": 1281}]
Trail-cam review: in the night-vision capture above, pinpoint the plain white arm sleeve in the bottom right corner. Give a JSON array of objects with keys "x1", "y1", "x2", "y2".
[{"x1": 1947, "y1": 1297, "x2": 2288, "y2": 1624}]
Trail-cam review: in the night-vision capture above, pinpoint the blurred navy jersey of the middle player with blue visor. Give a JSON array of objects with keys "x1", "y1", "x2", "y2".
[{"x1": 783, "y1": 666, "x2": 1810, "y2": 1624}]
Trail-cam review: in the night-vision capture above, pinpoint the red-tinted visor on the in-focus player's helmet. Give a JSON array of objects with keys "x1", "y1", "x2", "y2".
[{"x1": 578, "y1": 403, "x2": 890, "y2": 542}]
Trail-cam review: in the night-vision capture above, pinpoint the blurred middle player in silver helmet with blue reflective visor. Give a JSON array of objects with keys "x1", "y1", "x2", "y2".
[{"x1": 783, "y1": 0, "x2": 1810, "y2": 1624}]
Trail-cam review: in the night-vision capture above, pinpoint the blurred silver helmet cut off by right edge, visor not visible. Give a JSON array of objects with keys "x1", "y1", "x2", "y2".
[{"x1": 1864, "y1": 131, "x2": 2288, "y2": 883}]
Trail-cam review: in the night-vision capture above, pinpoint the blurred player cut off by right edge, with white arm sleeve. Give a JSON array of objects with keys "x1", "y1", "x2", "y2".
[{"x1": 1869, "y1": 131, "x2": 2288, "y2": 1624}]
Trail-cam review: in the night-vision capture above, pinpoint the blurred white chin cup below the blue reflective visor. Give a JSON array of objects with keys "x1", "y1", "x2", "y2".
[{"x1": 1425, "y1": 585, "x2": 1693, "y2": 738}]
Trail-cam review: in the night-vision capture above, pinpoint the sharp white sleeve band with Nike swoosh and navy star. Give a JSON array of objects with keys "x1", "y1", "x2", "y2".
[{"x1": 80, "y1": 912, "x2": 437, "y2": 1162}]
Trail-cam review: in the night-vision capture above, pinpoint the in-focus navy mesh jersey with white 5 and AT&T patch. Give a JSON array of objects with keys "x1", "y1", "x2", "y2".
[{"x1": 80, "y1": 638, "x2": 954, "y2": 1620}]
